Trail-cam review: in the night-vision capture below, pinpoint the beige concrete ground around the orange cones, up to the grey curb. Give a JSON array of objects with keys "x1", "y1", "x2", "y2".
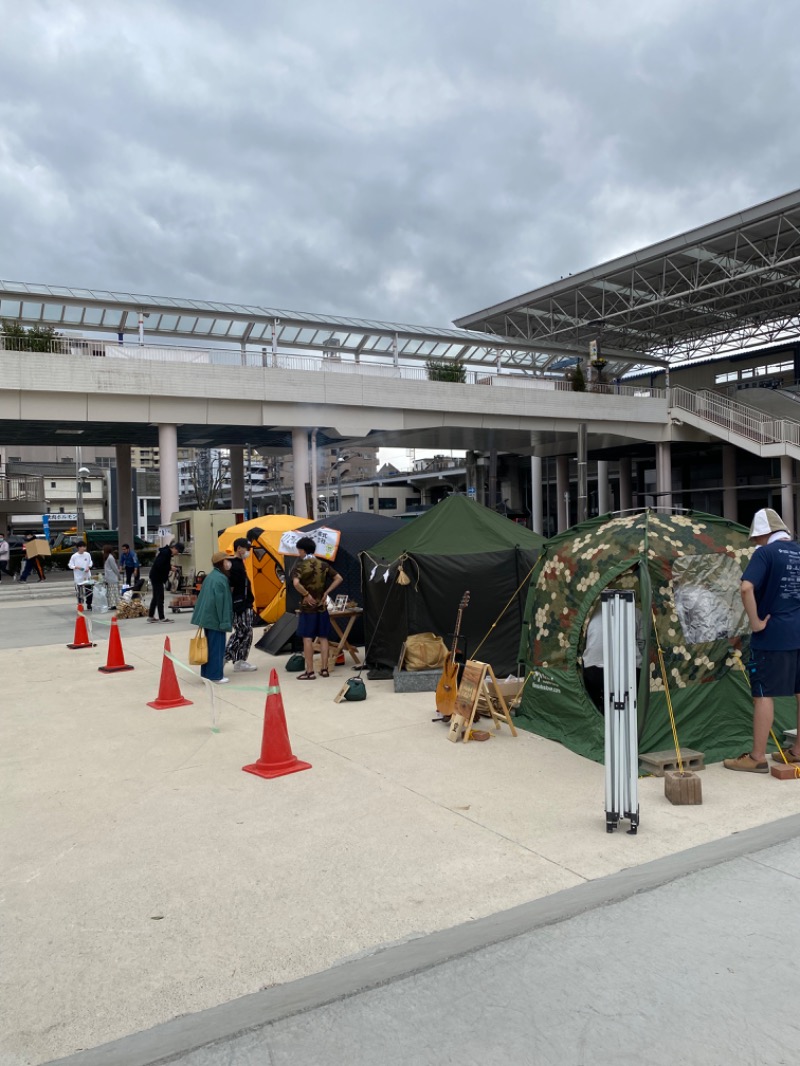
[{"x1": 0, "y1": 591, "x2": 800, "y2": 1066}]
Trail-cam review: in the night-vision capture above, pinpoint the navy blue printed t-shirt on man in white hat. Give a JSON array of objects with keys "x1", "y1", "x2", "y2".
[{"x1": 741, "y1": 540, "x2": 800, "y2": 651}]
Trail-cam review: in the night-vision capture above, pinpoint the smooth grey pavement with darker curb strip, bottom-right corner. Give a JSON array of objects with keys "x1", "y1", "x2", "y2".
[{"x1": 45, "y1": 815, "x2": 800, "y2": 1066}]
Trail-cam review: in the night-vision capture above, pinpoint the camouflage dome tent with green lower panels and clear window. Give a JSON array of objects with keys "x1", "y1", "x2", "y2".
[{"x1": 516, "y1": 511, "x2": 796, "y2": 762}]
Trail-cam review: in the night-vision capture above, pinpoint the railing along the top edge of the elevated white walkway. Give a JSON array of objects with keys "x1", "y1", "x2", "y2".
[{"x1": 0, "y1": 335, "x2": 667, "y2": 399}]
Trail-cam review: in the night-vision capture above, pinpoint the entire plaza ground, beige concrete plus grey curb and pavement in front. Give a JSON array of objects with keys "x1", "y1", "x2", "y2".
[{"x1": 0, "y1": 582, "x2": 800, "y2": 1066}]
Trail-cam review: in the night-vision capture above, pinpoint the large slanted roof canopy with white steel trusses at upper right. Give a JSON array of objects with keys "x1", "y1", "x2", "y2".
[{"x1": 455, "y1": 190, "x2": 800, "y2": 370}]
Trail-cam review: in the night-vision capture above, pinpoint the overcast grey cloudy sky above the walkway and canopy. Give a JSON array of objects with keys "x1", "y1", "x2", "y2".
[{"x1": 0, "y1": 0, "x2": 800, "y2": 325}]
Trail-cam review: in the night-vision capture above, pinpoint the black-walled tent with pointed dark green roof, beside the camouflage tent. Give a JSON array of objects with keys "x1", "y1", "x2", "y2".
[{"x1": 362, "y1": 496, "x2": 544, "y2": 677}]
